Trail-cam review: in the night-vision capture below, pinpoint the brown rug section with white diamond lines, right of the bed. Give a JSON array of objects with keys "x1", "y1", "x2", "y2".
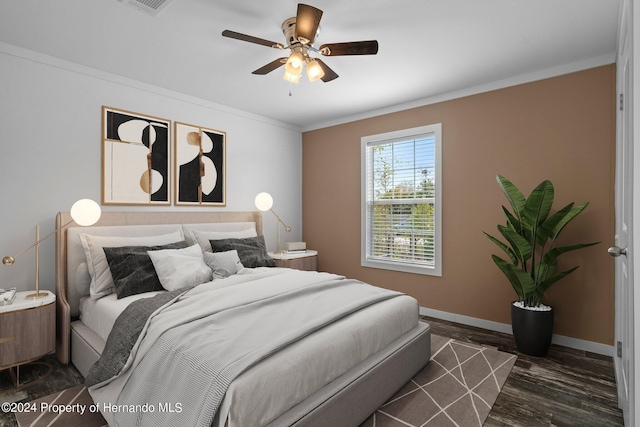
[{"x1": 361, "y1": 335, "x2": 517, "y2": 427}]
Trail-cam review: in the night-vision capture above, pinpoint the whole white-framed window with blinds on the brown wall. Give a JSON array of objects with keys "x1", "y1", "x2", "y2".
[{"x1": 361, "y1": 124, "x2": 442, "y2": 276}]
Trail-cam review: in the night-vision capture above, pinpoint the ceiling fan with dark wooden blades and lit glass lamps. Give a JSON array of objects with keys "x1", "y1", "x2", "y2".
[{"x1": 222, "y1": 3, "x2": 378, "y2": 83}]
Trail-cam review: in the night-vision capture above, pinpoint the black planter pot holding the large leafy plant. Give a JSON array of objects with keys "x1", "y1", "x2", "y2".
[{"x1": 511, "y1": 304, "x2": 553, "y2": 357}]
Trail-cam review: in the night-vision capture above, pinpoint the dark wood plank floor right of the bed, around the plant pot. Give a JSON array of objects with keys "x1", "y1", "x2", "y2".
[{"x1": 422, "y1": 316, "x2": 624, "y2": 427}]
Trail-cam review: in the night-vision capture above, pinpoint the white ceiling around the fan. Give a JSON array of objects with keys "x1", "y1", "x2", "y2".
[{"x1": 0, "y1": 0, "x2": 619, "y2": 130}]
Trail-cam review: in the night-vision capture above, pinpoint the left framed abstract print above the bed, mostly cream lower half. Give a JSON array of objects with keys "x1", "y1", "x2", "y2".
[{"x1": 102, "y1": 106, "x2": 171, "y2": 205}]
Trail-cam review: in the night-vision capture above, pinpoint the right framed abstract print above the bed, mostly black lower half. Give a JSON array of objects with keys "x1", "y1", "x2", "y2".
[{"x1": 173, "y1": 122, "x2": 226, "y2": 206}]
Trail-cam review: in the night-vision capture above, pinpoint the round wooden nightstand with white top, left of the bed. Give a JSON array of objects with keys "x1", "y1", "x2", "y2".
[{"x1": 0, "y1": 291, "x2": 56, "y2": 387}]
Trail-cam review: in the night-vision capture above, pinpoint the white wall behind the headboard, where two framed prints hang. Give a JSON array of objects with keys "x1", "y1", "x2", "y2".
[{"x1": 0, "y1": 44, "x2": 302, "y2": 290}]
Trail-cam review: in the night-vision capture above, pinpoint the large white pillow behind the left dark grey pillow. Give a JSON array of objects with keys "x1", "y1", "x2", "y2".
[{"x1": 78, "y1": 230, "x2": 184, "y2": 299}]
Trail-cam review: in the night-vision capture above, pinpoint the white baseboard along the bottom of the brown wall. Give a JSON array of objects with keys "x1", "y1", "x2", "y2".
[{"x1": 420, "y1": 307, "x2": 615, "y2": 357}]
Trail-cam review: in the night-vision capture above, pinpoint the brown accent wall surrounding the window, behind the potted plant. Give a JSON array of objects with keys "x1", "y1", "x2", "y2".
[{"x1": 302, "y1": 65, "x2": 615, "y2": 345}]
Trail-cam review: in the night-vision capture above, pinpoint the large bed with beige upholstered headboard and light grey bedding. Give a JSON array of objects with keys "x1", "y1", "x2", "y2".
[{"x1": 56, "y1": 211, "x2": 430, "y2": 427}]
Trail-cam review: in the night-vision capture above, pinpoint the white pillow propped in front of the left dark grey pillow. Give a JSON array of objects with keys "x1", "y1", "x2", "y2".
[{"x1": 147, "y1": 245, "x2": 211, "y2": 291}]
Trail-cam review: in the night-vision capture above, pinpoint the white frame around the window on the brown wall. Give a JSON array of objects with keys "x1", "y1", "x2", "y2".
[{"x1": 360, "y1": 123, "x2": 442, "y2": 277}]
